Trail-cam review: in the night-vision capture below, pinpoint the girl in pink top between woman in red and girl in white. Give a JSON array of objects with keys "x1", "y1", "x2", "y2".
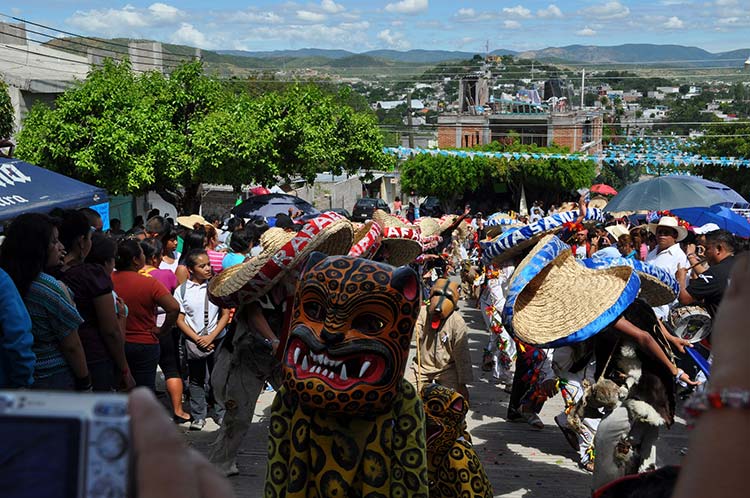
[{"x1": 139, "y1": 239, "x2": 190, "y2": 423}]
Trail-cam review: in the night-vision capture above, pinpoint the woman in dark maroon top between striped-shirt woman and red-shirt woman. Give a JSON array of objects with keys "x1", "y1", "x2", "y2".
[{"x1": 59, "y1": 209, "x2": 135, "y2": 392}]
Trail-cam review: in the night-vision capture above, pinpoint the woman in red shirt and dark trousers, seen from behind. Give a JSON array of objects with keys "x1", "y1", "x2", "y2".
[{"x1": 112, "y1": 240, "x2": 180, "y2": 391}]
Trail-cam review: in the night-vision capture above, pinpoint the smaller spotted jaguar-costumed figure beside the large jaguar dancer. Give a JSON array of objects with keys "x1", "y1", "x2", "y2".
[{"x1": 421, "y1": 384, "x2": 492, "y2": 498}]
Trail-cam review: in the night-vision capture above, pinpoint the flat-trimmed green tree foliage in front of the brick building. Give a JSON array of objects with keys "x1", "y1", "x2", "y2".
[{"x1": 400, "y1": 141, "x2": 596, "y2": 199}]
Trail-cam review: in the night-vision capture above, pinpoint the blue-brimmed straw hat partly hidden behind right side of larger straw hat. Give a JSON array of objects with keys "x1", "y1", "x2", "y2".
[{"x1": 580, "y1": 258, "x2": 680, "y2": 306}]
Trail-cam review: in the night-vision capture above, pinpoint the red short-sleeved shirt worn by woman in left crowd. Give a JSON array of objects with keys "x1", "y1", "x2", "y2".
[{"x1": 112, "y1": 271, "x2": 169, "y2": 344}]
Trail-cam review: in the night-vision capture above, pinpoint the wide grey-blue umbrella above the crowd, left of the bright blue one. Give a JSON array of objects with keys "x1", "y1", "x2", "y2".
[{"x1": 605, "y1": 176, "x2": 747, "y2": 212}]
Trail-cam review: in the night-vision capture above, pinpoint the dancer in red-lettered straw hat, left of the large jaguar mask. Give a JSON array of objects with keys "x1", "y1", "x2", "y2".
[{"x1": 209, "y1": 213, "x2": 353, "y2": 475}]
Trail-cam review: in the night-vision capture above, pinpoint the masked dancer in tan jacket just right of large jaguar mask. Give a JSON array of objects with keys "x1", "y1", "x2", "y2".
[{"x1": 413, "y1": 278, "x2": 474, "y2": 402}]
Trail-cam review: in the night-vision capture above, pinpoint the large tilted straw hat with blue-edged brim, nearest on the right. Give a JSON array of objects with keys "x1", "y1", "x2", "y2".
[{"x1": 503, "y1": 235, "x2": 640, "y2": 347}]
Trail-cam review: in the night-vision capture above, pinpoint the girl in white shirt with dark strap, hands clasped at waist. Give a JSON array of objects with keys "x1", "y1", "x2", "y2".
[{"x1": 174, "y1": 249, "x2": 229, "y2": 430}]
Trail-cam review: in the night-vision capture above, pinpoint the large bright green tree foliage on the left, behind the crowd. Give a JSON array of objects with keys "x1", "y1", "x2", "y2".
[{"x1": 17, "y1": 61, "x2": 393, "y2": 212}]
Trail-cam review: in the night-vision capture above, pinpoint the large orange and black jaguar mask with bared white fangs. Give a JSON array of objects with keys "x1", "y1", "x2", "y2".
[{"x1": 284, "y1": 253, "x2": 419, "y2": 415}]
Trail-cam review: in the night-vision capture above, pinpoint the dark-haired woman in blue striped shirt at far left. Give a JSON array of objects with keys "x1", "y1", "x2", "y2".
[{"x1": 0, "y1": 213, "x2": 91, "y2": 390}]
